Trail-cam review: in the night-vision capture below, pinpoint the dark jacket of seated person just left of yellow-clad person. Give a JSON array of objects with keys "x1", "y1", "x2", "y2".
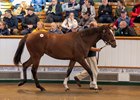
[{"x1": 22, "y1": 13, "x2": 39, "y2": 29}]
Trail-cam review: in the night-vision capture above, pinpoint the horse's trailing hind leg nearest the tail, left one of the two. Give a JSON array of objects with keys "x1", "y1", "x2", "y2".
[{"x1": 18, "y1": 58, "x2": 32, "y2": 86}]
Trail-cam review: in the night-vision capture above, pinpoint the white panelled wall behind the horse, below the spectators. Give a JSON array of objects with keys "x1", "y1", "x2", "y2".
[{"x1": 0, "y1": 38, "x2": 140, "y2": 67}]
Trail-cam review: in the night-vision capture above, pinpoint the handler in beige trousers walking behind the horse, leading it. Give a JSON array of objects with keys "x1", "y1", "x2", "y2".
[{"x1": 74, "y1": 21, "x2": 101, "y2": 90}]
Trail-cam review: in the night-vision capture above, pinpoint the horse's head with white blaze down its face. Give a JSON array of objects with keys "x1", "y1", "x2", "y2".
[{"x1": 101, "y1": 25, "x2": 117, "y2": 48}]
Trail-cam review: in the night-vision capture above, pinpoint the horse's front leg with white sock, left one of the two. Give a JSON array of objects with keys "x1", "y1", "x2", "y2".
[{"x1": 63, "y1": 60, "x2": 76, "y2": 91}]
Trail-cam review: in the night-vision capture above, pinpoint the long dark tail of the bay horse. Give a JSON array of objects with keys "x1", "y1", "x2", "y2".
[{"x1": 13, "y1": 35, "x2": 28, "y2": 66}]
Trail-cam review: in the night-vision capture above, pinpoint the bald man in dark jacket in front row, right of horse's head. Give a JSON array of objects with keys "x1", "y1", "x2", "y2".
[{"x1": 115, "y1": 21, "x2": 137, "y2": 36}]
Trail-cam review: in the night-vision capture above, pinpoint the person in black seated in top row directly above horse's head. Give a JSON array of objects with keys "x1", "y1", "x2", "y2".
[{"x1": 98, "y1": 0, "x2": 113, "y2": 23}]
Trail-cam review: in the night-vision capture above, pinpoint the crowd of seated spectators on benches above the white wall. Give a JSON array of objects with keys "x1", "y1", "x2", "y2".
[{"x1": 0, "y1": 0, "x2": 140, "y2": 36}]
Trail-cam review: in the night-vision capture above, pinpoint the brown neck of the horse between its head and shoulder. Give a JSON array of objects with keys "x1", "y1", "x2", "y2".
[{"x1": 82, "y1": 28, "x2": 100, "y2": 46}]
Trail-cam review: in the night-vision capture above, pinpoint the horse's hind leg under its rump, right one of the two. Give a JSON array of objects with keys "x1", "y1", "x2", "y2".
[{"x1": 31, "y1": 58, "x2": 45, "y2": 91}]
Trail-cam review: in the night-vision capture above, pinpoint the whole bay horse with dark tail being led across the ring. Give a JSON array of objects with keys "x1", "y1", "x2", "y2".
[{"x1": 13, "y1": 25, "x2": 116, "y2": 91}]
